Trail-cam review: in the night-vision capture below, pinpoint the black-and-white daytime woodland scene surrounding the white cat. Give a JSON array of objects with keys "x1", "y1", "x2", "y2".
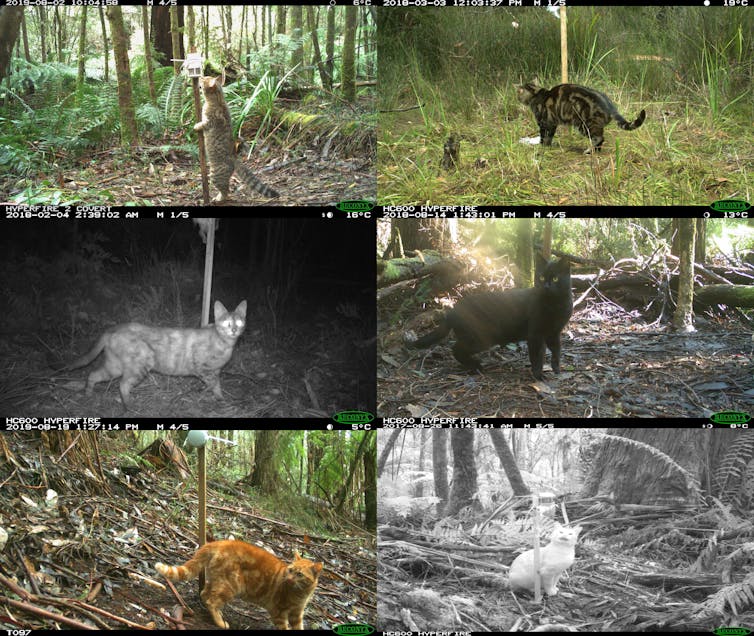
[{"x1": 378, "y1": 427, "x2": 754, "y2": 633}]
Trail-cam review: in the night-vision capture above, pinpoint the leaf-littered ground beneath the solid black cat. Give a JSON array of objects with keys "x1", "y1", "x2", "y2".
[{"x1": 377, "y1": 305, "x2": 754, "y2": 419}]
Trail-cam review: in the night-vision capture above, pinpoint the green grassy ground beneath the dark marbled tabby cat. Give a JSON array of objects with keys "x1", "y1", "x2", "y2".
[{"x1": 377, "y1": 80, "x2": 754, "y2": 206}]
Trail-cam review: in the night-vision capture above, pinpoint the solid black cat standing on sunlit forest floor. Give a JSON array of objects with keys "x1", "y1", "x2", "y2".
[{"x1": 408, "y1": 254, "x2": 573, "y2": 380}]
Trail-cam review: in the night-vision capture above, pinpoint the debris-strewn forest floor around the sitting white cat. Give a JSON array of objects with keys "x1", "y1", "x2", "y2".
[{"x1": 377, "y1": 506, "x2": 754, "y2": 633}]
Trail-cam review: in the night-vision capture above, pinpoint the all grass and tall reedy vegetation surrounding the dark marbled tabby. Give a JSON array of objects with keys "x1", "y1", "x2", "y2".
[{"x1": 378, "y1": 7, "x2": 754, "y2": 206}]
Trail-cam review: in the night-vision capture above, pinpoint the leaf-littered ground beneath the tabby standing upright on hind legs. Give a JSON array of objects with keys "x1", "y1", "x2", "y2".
[{"x1": 0, "y1": 146, "x2": 377, "y2": 207}]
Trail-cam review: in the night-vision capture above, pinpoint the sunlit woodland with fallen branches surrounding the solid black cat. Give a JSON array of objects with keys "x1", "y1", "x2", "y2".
[{"x1": 377, "y1": 219, "x2": 754, "y2": 418}]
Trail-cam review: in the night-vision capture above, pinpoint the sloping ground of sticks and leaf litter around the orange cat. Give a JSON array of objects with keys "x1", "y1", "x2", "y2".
[{"x1": 0, "y1": 434, "x2": 377, "y2": 630}]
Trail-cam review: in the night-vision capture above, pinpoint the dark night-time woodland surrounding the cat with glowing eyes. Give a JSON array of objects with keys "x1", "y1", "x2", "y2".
[{"x1": 0, "y1": 218, "x2": 376, "y2": 418}]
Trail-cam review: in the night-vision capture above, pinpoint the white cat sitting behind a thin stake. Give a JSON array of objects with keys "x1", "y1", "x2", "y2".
[{"x1": 508, "y1": 523, "x2": 581, "y2": 596}]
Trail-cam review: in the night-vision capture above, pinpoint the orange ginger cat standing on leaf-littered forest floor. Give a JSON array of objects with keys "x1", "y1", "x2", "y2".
[{"x1": 154, "y1": 541, "x2": 322, "y2": 629}]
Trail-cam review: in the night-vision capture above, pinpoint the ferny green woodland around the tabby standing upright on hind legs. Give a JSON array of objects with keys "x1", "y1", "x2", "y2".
[{"x1": 0, "y1": 5, "x2": 376, "y2": 206}]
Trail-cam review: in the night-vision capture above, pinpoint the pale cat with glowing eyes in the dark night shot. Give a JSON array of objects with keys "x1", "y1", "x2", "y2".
[{"x1": 53, "y1": 300, "x2": 246, "y2": 408}]
